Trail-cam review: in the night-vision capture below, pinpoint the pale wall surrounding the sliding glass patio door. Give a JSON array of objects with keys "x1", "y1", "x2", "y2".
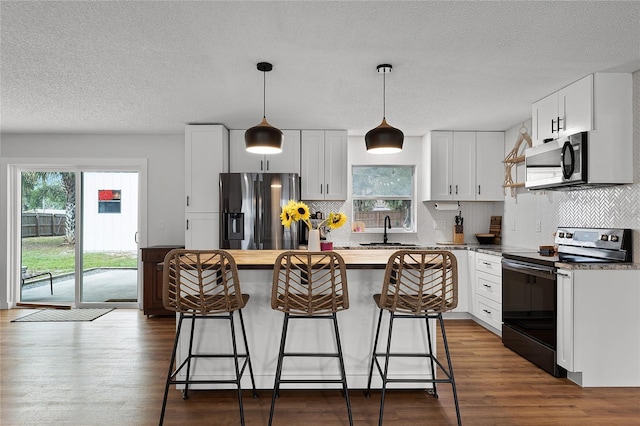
[{"x1": 0, "y1": 134, "x2": 184, "y2": 308}]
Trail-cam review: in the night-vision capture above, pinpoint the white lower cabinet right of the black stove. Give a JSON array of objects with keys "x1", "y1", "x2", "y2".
[{"x1": 556, "y1": 269, "x2": 640, "y2": 387}]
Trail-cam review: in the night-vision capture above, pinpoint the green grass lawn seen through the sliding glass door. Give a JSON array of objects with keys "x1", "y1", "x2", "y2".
[{"x1": 22, "y1": 236, "x2": 138, "y2": 275}]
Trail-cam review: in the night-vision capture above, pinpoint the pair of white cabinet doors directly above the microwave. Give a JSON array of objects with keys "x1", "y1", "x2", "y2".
[{"x1": 531, "y1": 74, "x2": 594, "y2": 145}]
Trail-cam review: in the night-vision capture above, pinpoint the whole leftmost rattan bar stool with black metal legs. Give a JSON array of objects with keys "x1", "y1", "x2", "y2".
[{"x1": 160, "y1": 249, "x2": 257, "y2": 425}]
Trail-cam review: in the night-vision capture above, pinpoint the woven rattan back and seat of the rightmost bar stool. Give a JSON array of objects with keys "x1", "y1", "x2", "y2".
[{"x1": 379, "y1": 250, "x2": 458, "y2": 315}]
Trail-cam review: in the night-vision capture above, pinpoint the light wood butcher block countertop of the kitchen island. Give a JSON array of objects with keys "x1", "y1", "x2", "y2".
[{"x1": 225, "y1": 249, "x2": 396, "y2": 269}]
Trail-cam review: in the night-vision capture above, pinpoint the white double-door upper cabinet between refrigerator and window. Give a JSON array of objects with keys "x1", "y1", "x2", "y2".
[{"x1": 301, "y1": 130, "x2": 348, "y2": 200}]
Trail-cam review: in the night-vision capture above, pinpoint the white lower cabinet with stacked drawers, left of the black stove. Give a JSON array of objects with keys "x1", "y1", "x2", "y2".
[{"x1": 470, "y1": 253, "x2": 502, "y2": 333}]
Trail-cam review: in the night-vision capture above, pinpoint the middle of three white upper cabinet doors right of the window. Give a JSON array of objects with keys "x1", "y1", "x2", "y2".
[{"x1": 451, "y1": 132, "x2": 476, "y2": 201}]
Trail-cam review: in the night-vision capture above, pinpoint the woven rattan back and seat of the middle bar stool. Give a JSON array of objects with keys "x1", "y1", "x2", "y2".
[{"x1": 271, "y1": 251, "x2": 349, "y2": 315}]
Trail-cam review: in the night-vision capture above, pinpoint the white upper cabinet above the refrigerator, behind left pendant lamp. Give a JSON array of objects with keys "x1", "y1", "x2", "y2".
[{"x1": 229, "y1": 130, "x2": 300, "y2": 174}]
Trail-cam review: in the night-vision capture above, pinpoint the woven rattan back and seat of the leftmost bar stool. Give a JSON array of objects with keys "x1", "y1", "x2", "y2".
[{"x1": 162, "y1": 249, "x2": 246, "y2": 315}]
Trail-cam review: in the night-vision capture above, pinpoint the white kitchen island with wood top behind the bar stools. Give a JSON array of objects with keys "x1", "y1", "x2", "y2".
[{"x1": 171, "y1": 249, "x2": 466, "y2": 389}]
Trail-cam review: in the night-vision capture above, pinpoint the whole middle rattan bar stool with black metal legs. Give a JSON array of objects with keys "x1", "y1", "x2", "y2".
[{"x1": 269, "y1": 251, "x2": 353, "y2": 425}]
